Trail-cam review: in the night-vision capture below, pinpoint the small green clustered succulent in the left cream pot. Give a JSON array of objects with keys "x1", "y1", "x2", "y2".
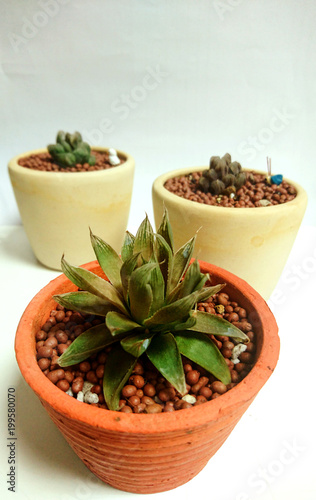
[{"x1": 47, "y1": 130, "x2": 96, "y2": 168}]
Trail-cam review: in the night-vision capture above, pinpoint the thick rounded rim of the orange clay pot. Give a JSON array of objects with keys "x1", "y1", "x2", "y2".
[{"x1": 15, "y1": 261, "x2": 280, "y2": 434}]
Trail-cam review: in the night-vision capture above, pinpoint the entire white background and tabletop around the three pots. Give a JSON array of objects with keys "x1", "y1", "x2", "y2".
[{"x1": 0, "y1": 0, "x2": 316, "y2": 500}]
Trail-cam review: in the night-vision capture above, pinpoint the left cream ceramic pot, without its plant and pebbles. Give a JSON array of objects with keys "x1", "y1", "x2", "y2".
[{"x1": 8, "y1": 147, "x2": 135, "y2": 270}]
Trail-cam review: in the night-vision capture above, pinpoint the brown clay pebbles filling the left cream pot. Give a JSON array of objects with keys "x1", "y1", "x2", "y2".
[{"x1": 18, "y1": 148, "x2": 124, "y2": 173}]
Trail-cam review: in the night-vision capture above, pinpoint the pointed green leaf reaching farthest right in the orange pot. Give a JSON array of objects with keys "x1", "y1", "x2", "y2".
[{"x1": 188, "y1": 311, "x2": 249, "y2": 342}]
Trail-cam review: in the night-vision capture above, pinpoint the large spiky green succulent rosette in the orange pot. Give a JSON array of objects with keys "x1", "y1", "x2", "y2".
[{"x1": 54, "y1": 211, "x2": 249, "y2": 410}]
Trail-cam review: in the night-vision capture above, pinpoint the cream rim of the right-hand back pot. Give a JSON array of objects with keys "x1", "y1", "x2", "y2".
[{"x1": 152, "y1": 166, "x2": 307, "y2": 217}]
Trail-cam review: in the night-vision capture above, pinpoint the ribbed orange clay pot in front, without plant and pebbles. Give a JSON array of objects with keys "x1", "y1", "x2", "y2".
[{"x1": 15, "y1": 262, "x2": 279, "y2": 493}]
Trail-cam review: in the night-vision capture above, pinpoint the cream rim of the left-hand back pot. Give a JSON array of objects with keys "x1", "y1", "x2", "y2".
[{"x1": 8, "y1": 146, "x2": 135, "y2": 181}]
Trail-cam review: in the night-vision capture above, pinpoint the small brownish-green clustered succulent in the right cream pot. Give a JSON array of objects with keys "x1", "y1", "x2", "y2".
[{"x1": 199, "y1": 153, "x2": 247, "y2": 195}]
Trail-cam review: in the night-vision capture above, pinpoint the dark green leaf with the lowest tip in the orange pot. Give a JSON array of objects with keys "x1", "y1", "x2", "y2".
[{"x1": 103, "y1": 346, "x2": 137, "y2": 411}]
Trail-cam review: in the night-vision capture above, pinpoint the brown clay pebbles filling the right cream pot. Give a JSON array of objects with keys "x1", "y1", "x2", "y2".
[{"x1": 164, "y1": 171, "x2": 297, "y2": 208}]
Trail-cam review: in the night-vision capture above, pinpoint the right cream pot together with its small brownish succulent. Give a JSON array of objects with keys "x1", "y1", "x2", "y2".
[{"x1": 152, "y1": 154, "x2": 307, "y2": 299}]
